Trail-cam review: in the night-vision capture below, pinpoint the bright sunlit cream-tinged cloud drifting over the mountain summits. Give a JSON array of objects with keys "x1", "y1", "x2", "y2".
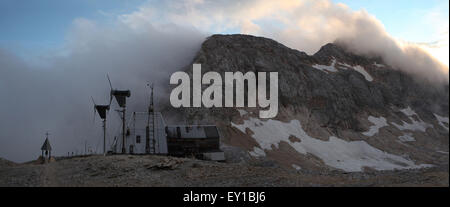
[{"x1": 122, "y1": 0, "x2": 448, "y2": 82}]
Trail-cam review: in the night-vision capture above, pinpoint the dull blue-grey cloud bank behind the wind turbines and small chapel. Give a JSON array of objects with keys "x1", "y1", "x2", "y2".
[{"x1": 0, "y1": 16, "x2": 206, "y2": 162}]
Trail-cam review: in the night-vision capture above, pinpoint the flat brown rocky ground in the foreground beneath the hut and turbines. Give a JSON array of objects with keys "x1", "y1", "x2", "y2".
[{"x1": 0, "y1": 155, "x2": 449, "y2": 187}]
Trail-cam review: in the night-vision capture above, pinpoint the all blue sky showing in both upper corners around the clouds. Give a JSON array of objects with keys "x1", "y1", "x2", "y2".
[{"x1": 0, "y1": 0, "x2": 449, "y2": 62}]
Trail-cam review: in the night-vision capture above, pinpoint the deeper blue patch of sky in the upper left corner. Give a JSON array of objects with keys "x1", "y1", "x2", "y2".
[{"x1": 0, "y1": 0, "x2": 145, "y2": 58}]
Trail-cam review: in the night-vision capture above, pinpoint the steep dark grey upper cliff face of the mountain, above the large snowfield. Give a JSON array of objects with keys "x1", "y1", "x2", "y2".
[{"x1": 178, "y1": 35, "x2": 449, "y2": 130}]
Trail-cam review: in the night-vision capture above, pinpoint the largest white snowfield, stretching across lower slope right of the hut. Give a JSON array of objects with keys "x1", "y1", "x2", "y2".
[{"x1": 231, "y1": 118, "x2": 431, "y2": 172}]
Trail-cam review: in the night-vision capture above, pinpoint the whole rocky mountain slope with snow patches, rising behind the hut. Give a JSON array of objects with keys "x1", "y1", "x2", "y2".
[{"x1": 167, "y1": 35, "x2": 449, "y2": 171}]
